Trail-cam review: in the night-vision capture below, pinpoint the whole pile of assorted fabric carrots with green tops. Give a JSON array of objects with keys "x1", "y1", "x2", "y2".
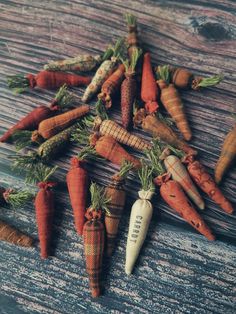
[{"x1": 0, "y1": 14, "x2": 236, "y2": 297}]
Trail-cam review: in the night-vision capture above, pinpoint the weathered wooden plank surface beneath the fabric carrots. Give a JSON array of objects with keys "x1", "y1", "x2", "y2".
[{"x1": 0, "y1": 0, "x2": 236, "y2": 314}]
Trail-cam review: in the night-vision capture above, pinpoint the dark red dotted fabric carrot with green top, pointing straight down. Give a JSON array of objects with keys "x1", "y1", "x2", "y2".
[{"x1": 121, "y1": 47, "x2": 142, "y2": 129}]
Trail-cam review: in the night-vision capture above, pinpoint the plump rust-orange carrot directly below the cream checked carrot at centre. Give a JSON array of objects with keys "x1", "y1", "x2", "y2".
[{"x1": 90, "y1": 134, "x2": 141, "y2": 168}]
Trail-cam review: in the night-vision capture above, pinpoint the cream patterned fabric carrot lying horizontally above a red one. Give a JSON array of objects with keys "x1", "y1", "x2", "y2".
[{"x1": 44, "y1": 54, "x2": 102, "y2": 72}]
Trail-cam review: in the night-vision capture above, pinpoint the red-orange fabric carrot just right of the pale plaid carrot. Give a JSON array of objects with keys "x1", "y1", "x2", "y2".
[{"x1": 183, "y1": 155, "x2": 234, "y2": 214}]
